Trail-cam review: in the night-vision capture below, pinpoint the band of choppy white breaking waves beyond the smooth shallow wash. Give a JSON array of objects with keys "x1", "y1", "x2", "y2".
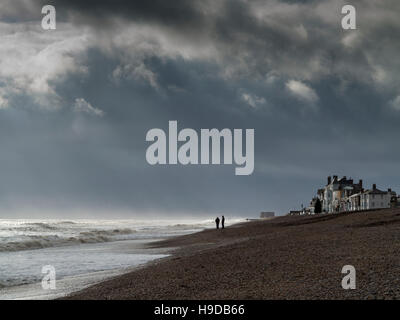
[{"x1": 0, "y1": 220, "x2": 222, "y2": 252}]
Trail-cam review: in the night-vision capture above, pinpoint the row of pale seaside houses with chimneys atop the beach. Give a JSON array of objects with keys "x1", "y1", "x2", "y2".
[{"x1": 289, "y1": 176, "x2": 400, "y2": 215}]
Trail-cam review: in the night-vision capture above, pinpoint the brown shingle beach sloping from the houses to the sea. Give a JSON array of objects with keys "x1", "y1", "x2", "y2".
[{"x1": 65, "y1": 209, "x2": 400, "y2": 299}]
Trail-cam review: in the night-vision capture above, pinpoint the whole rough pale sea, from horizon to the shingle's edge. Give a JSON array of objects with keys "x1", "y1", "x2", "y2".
[{"x1": 0, "y1": 219, "x2": 244, "y2": 300}]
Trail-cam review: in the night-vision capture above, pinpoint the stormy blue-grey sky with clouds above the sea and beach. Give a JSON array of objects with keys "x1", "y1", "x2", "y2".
[{"x1": 0, "y1": 0, "x2": 400, "y2": 218}]
